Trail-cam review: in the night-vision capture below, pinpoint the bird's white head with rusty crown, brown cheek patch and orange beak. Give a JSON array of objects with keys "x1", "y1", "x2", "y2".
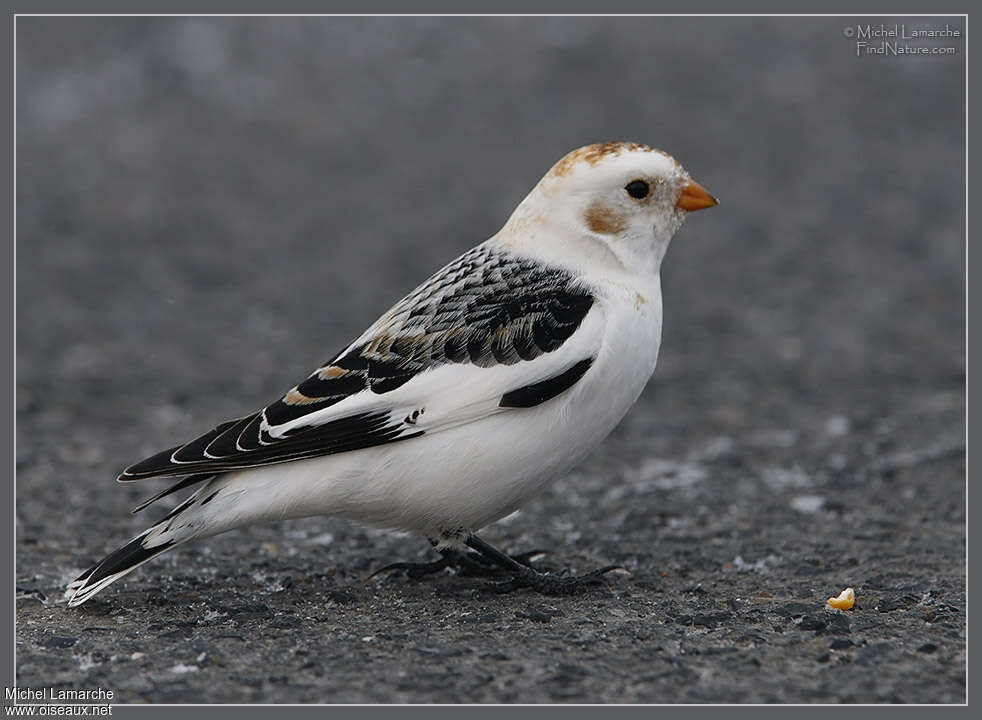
[{"x1": 503, "y1": 142, "x2": 718, "y2": 272}]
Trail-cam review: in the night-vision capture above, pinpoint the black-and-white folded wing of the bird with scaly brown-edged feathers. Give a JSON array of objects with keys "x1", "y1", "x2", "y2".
[{"x1": 119, "y1": 244, "x2": 603, "y2": 481}]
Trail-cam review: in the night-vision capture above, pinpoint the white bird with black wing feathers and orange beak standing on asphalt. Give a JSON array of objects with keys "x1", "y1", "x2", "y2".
[{"x1": 66, "y1": 142, "x2": 718, "y2": 607}]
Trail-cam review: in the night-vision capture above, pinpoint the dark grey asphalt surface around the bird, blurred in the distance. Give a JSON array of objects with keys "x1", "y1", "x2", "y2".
[{"x1": 17, "y1": 18, "x2": 965, "y2": 703}]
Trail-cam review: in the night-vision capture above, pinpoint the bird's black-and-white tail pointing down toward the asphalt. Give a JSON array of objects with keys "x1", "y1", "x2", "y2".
[{"x1": 65, "y1": 493, "x2": 198, "y2": 607}]
